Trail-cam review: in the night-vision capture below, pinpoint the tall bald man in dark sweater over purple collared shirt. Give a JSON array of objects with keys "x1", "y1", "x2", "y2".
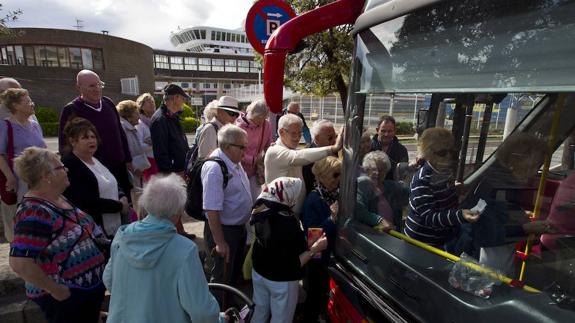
[{"x1": 58, "y1": 70, "x2": 132, "y2": 202}]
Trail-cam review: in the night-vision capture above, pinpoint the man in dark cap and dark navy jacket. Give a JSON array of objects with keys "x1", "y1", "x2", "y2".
[{"x1": 150, "y1": 84, "x2": 190, "y2": 175}]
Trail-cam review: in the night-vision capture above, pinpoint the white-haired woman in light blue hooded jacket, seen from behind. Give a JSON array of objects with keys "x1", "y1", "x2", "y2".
[{"x1": 104, "y1": 173, "x2": 223, "y2": 323}]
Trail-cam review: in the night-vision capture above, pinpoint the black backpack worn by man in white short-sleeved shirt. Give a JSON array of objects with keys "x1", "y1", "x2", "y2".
[{"x1": 186, "y1": 157, "x2": 229, "y2": 221}]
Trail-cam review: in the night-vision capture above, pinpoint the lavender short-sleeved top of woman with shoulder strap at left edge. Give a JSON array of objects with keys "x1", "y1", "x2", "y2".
[{"x1": 0, "y1": 120, "x2": 46, "y2": 156}]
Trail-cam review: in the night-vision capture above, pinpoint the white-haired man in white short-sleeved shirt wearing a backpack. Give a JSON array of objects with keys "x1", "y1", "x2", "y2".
[{"x1": 201, "y1": 124, "x2": 252, "y2": 286}]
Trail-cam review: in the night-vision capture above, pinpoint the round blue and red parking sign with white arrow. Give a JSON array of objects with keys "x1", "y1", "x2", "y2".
[{"x1": 246, "y1": 0, "x2": 296, "y2": 55}]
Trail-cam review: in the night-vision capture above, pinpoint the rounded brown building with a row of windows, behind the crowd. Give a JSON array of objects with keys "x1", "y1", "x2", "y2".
[{"x1": 0, "y1": 28, "x2": 154, "y2": 109}]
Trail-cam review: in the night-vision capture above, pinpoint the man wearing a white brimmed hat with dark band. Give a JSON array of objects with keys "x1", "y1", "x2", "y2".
[{"x1": 197, "y1": 96, "x2": 240, "y2": 158}]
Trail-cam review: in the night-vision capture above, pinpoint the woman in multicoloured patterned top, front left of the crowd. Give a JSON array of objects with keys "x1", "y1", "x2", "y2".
[{"x1": 10, "y1": 147, "x2": 105, "y2": 323}]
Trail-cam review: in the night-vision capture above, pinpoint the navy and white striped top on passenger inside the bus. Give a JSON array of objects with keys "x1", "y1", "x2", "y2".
[{"x1": 404, "y1": 162, "x2": 466, "y2": 248}]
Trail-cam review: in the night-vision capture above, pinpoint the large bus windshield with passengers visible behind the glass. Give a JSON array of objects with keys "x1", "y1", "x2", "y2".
[{"x1": 335, "y1": 0, "x2": 575, "y2": 321}]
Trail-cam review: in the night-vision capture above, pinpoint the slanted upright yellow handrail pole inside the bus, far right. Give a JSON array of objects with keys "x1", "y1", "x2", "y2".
[{"x1": 519, "y1": 94, "x2": 566, "y2": 282}]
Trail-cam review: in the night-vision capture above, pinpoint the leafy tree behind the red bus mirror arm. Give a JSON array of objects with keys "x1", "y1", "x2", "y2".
[{"x1": 284, "y1": 0, "x2": 353, "y2": 106}]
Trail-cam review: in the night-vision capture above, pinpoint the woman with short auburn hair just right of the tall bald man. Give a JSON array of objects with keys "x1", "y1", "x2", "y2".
[{"x1": 116, "y1": 100, "x2": 150, "y2": 188}]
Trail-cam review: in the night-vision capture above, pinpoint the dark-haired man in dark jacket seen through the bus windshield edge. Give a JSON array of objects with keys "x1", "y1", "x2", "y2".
[{"x1": 371, "y1": 116, "x2": 408, "y2": 180}]
